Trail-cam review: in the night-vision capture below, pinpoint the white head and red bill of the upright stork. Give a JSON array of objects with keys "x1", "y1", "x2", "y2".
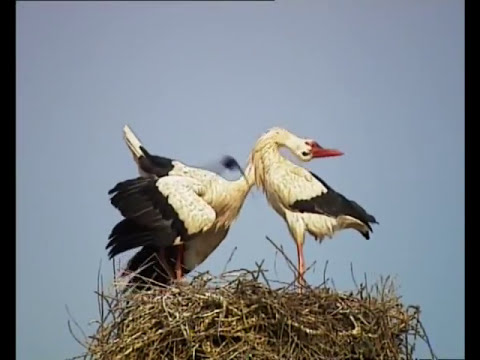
[{"x1": 263, "y1": 127, "x2": 343, "y2": 162}]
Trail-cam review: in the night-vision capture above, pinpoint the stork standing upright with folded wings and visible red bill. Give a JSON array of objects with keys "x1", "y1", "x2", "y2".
[{"x1": 251, "y1": 127, "x2": 378, "y2": 289}]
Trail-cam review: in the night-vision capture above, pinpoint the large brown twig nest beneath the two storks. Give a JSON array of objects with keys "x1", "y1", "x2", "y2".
[{"x1": 70, "y1": 260, "x2": 435, "y2": 360}]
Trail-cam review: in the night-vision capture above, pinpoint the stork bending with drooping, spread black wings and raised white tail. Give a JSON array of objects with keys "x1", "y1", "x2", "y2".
[{"x1": 107, "y1": 126, "x2": 254, "y2": 283}]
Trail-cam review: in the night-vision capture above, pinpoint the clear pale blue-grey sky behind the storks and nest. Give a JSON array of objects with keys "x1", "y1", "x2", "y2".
[{"x1": 16, "y1": 0, "x2": 465, "y2": 360}]
